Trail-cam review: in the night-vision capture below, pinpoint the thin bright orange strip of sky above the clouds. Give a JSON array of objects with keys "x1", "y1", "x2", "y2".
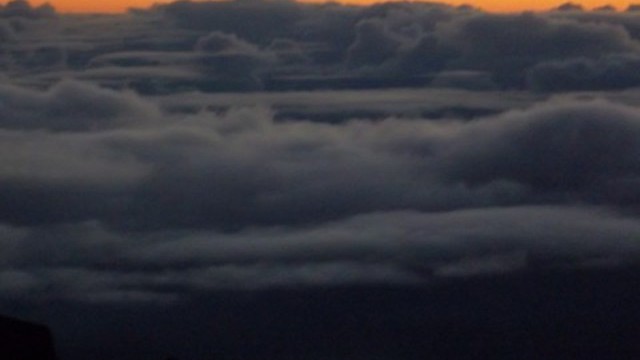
[{"x1": 0, "y1": 0, "x2": 640, "y2": 12}]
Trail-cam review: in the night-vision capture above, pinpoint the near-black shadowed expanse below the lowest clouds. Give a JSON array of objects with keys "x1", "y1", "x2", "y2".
[{"x1": 2, "y1": 267, "x2": 640, "y2": 360}]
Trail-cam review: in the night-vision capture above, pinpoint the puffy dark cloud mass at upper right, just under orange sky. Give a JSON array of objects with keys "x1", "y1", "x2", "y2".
[{"x1": 438, "y1": 13, "x2": 639, "y2": 86}]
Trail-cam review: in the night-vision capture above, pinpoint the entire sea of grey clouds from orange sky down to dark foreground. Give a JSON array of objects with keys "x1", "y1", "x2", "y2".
[{"x1": 0, "y1": 0, "x2": 640, "y2": 303}]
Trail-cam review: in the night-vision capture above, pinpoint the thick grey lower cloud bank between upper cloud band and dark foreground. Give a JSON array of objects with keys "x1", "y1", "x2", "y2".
[{"x1": 0, "y1": 76, "x2": 640, "y2": 301}]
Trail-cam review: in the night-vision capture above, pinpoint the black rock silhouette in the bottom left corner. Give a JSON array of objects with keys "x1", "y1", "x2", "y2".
[{"x1": 0, "y1": 316, "x2": 57, "y2": 360}]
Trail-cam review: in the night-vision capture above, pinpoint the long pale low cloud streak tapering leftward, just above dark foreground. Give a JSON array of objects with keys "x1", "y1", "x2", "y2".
[{"x1": 127, "y1": 206, "x2": 638, "y2": 270}]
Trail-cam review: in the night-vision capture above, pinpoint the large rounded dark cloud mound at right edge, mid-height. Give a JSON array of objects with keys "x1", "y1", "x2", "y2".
[{"x1": 443, "y1": 97, "x2": 640, "y2": 196}]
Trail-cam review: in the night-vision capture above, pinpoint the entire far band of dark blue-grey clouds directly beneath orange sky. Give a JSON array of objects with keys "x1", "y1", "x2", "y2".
[{"x1": 2, "y1": 1, "x2": 640, "y2": 94}]
